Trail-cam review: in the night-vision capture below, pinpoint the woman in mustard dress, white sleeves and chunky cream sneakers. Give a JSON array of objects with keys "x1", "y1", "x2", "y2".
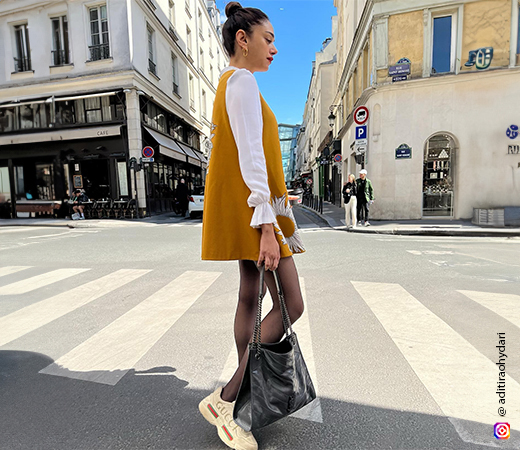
[{"x1": 199, "y1": 2, "x2": 305, "y2": 450}]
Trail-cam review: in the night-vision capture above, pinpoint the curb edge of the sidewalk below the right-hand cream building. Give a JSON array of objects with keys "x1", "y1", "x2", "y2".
[{"x1": 299, "y1": 205, "x2": 520, "y2": 237}]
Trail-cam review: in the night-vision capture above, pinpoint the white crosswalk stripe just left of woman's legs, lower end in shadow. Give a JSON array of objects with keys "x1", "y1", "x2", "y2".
[{"x1": 40, "y1": 271, "x2": 220, "y2": 386}]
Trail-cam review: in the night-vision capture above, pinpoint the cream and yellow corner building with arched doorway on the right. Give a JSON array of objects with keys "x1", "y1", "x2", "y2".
[{"x1": 333, "y1": 0, "x2": 520, "y2": 220}]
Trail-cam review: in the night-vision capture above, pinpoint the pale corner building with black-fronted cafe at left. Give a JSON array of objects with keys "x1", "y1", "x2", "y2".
[{"x1": 0, "y1": 0, "x2": 227, "y2": 216}]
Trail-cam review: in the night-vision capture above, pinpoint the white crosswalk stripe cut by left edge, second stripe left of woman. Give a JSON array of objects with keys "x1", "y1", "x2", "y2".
[{"x1": 0, "y1": 269, "x2": 150, "y2": 347}]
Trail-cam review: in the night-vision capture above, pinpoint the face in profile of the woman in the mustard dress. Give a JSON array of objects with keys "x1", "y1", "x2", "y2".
[{"x1": 237, "y1": 21, "x2": 278, "y2": 72}]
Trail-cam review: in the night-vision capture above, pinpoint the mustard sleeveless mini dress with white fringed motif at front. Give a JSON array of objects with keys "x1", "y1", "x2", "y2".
[{"x1": 202, "y1": 70, "x2": 305, "y2": 261}]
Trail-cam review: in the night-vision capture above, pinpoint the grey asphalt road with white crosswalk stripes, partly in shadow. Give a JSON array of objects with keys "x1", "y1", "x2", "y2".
[{"x1": 0, "y1": 210, "x2": 520, "y2": 450}]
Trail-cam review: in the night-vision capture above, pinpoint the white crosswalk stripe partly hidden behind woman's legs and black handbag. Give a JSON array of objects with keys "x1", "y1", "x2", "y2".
[{"x1": 215, "y1": 277, "x2": 323, "y2": 423}]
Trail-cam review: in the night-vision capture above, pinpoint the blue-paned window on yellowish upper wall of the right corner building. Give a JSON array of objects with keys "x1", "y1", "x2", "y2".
[{"x1": 431, "y1": 15, "x2": 455, "y2": 74}]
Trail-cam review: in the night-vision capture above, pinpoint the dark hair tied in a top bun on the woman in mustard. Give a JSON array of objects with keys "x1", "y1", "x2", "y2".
[{"x1": 222, "y1": 2, "x2": 269, "y2": 57}]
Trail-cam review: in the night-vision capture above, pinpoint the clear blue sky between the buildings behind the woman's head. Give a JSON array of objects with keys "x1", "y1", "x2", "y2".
[{"x1": 217, "y1": 0, "x2": 336, "y2": 124}]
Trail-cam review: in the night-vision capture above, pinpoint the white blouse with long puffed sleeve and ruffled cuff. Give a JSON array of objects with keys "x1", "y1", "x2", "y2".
[{"x1": 220, "y1": 66, "x2": 276, "y2": 228}]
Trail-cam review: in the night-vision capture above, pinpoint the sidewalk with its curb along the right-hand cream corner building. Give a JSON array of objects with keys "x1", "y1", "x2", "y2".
[{"x1": 300, "y1": 202, "x2": 520, "y2": 237}]
